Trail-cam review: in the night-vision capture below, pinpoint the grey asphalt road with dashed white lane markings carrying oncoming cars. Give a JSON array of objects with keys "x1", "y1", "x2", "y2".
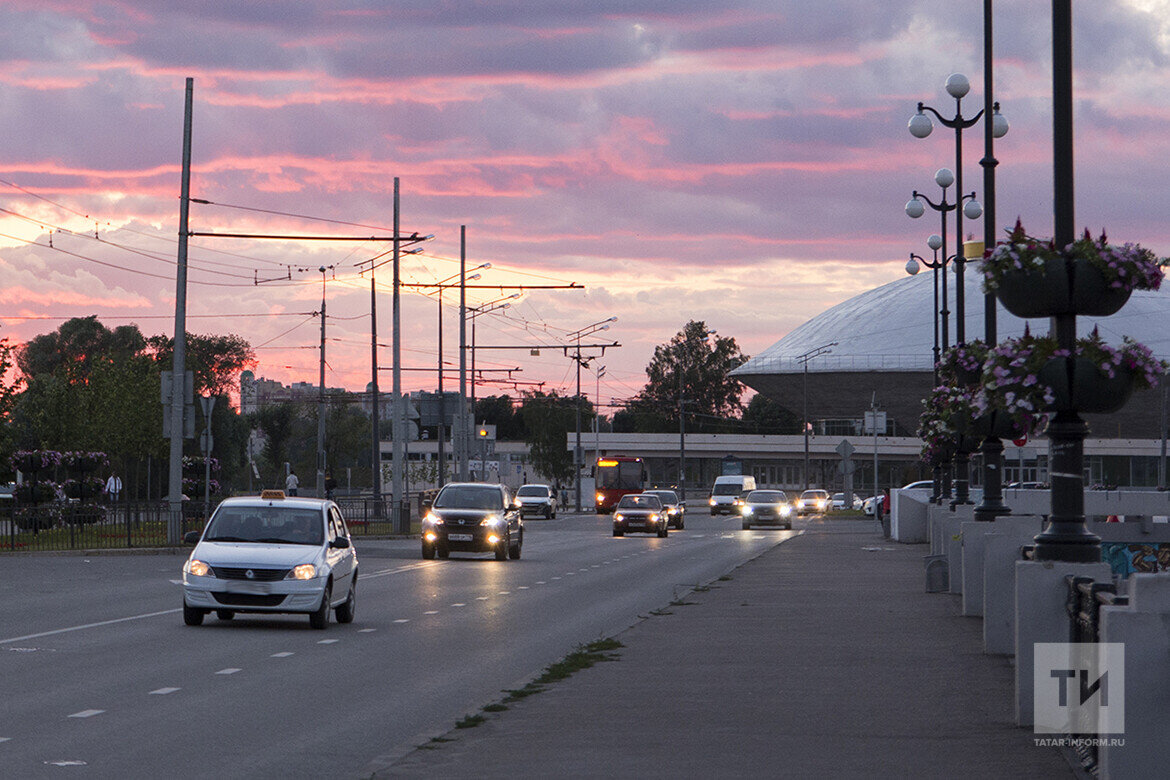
[{"x1": 0, "y1": 513, "x2": 793, "y2": 778}]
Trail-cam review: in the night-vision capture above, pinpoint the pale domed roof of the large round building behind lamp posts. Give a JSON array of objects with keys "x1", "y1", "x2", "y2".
[{"x1": 731, "y1": 268, "x2": 1170, "y2": 378}]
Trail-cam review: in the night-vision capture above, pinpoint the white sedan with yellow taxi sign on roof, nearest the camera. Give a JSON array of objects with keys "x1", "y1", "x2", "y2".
[{"x1": 183, "y1": 490, "x2": 358, "y2": 628}]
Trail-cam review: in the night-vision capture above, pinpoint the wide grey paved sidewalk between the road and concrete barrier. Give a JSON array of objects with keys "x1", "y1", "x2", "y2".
[{"x1": 378, "y1": 520, "x2": 1073, "y2": 778}]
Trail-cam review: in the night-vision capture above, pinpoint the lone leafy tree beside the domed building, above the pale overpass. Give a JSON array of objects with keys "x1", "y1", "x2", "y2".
[{"x1": 632, "y1": 319, "x2": 748, "y2": 430}]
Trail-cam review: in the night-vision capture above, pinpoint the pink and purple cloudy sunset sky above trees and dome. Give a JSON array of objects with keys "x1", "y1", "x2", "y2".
[{"x1": 0, "y1": 0, "x2": 1170, "y2": 409}]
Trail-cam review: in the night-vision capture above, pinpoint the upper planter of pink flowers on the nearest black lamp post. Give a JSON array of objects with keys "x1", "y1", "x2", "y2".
[{"x1": 982, "y1": 220, "x2": 1166, "y2": 318}]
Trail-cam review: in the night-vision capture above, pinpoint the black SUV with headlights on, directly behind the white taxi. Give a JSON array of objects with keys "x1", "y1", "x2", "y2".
[{"x1": 422, "y1": 482, "x2": 524, "y2": 560}]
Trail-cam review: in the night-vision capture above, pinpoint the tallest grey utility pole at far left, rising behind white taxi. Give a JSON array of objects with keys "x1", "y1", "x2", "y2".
[{"x1": 166, "y1": 77, "x2": 195, "y2": 545}]
